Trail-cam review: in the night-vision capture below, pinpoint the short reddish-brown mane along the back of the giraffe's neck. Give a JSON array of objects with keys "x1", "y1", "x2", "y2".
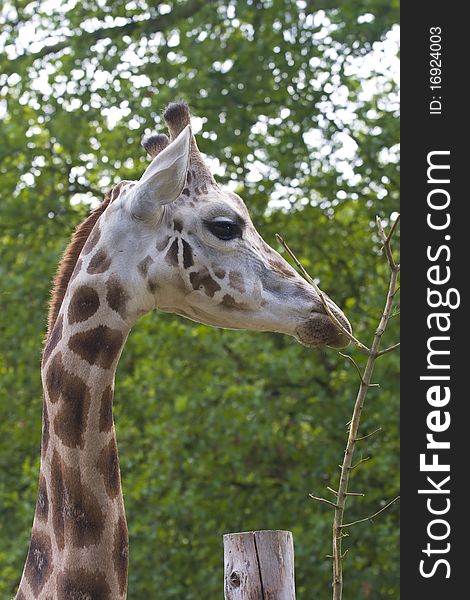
[{"x1": 44, "y1": 192, "x2": 111, "y2": 342}]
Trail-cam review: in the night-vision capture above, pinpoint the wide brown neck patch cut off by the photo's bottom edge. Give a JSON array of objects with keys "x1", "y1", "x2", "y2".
[{"x1": 57, "y1": 569, "x2": 112, "y2": 600}]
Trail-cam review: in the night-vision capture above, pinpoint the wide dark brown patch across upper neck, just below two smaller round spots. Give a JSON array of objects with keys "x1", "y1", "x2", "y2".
[{"x1": 69, "y1": 325, "x2": 124, "y2": 369}]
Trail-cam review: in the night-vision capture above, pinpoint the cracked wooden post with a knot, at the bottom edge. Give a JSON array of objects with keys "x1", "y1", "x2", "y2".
[{"x1": 224, "y1": 531, "x2": 295, "y2": 600}]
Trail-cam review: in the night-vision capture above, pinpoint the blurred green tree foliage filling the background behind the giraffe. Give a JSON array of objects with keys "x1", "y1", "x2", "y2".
[{"x1": 0, "y1": 0, "x2": 398, "y2": 600}]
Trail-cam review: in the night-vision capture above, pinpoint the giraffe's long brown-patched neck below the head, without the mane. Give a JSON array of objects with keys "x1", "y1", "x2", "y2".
[{"x1": 17, "y1": 276, "x2": 133, "y2": 600}]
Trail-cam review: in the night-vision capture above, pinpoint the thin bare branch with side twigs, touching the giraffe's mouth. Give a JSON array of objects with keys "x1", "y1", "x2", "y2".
[{"x1": 277, "y1": 216, "x2": 400, "y2": 600}]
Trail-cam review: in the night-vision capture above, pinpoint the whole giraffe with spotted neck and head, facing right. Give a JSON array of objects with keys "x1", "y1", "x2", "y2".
[{"x1": 15, "y1": 101, "x2": 351, "y2": 600}]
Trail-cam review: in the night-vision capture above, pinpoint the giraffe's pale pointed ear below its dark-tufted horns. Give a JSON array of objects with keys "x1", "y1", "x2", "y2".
[{"x1": 131, "y1": 125, "x2": 192, "y2": 220}]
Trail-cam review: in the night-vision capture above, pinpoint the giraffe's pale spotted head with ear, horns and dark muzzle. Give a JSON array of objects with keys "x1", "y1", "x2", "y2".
[{"x1": 84, "y1": 102, "x2": 350, "y2": 347}]
